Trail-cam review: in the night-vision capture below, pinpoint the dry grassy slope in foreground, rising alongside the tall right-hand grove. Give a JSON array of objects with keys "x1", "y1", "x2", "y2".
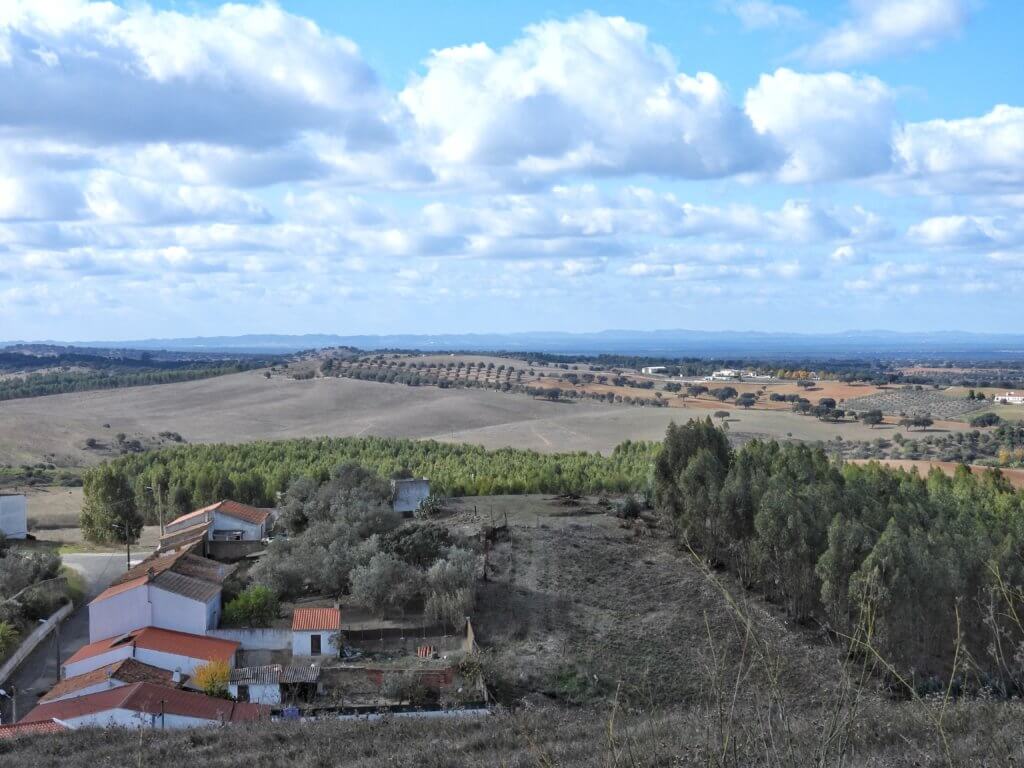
[{"x1": 0, "y1": 497, "x2": 1024, "y2": 768}]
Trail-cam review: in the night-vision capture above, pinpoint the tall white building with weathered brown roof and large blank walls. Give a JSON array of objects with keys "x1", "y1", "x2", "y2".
[{"x1": 89, "y1": 550, "x2": 233, "y2": 642}]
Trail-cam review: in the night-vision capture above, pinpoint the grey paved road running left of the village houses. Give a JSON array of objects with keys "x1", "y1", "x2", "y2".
[{"x1": 0, "y1": 551, "x2": 147, "y2": 723}]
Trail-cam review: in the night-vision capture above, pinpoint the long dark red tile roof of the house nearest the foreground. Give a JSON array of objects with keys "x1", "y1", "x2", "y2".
[{"x1": 22, "y1": 683, "x2": 270, "y2": 723}]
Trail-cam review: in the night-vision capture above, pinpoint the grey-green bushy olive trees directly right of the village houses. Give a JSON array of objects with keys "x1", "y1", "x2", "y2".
[{"x1": 247, "y1": 464, "x2": 476, "y2": 627}]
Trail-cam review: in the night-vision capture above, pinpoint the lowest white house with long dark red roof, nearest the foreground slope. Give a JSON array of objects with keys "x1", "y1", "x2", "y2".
[{"x1": 22, "y1": 683, "x2": 270, "y2": 730}]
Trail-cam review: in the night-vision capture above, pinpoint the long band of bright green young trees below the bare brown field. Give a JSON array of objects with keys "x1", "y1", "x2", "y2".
[{"x1": 82, "y1": 437, "x2": 657, "y2": 541}]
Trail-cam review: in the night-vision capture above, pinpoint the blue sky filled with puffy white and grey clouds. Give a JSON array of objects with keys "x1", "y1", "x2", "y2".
[{"x1": 0, "y1": 0, "x2": 1024, "y2": 340}]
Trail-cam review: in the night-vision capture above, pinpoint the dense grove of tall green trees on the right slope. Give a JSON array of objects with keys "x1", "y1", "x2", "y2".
[{"x1": 654, "y1": 420, "x2": 1024, "y2": 693}]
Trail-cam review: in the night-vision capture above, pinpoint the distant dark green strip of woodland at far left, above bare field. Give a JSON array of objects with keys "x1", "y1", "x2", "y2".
[{"x1": 0, "y1": 361, "x2": 262, "y2": 400}]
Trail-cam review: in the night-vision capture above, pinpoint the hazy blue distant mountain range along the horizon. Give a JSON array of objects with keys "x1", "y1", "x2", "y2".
[{"x1": 6, "y1": 330, "x2": 1024, "y2": 360}]
